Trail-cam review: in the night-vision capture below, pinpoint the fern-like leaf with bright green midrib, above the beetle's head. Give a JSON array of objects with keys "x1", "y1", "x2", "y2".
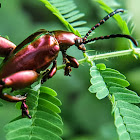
[{"x1": 40, "y1": 0, "x2": 89, "y2": 36}]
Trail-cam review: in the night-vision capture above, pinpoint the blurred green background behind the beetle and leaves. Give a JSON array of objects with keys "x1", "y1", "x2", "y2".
[{"x1": 0, "y1": 0, "x2": 140, "y2": 140}]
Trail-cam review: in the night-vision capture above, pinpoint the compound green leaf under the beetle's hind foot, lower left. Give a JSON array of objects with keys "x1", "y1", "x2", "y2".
[{"x1": 5, "y1": 87, "x2": 63, "y2": 140}]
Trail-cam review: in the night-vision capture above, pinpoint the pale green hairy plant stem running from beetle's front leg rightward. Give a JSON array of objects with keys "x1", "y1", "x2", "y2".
[{"x1": 57, "y1": 48, "x2": 140, "y2": 70}]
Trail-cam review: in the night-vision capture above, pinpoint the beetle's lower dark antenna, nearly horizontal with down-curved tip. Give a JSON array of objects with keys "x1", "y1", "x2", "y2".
[{"x1": 82, "y1": 34, "x2": 138, "y2": 46}]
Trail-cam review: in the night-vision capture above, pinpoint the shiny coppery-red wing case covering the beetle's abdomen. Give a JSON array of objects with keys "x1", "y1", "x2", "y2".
[{"x1": 0, "y1": 34, "x2": 60, "y2": 79}]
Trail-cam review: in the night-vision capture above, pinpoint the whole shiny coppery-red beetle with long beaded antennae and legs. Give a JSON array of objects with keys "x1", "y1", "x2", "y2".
[{"x1": 0, "y1": 9, "x2": 138, "y2": 118}]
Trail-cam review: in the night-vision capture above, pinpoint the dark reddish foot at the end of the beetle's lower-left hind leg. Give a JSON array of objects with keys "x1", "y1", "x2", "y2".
[{"x1": 21, "y1": 100, "x2": 32, "y2": 119}]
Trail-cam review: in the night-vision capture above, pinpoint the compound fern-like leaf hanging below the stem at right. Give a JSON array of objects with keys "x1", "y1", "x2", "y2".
[{"x1": 89, "y1": 64, "x2": 140, "y2": 140}]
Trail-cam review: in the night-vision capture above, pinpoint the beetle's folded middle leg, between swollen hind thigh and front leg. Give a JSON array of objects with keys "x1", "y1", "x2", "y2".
[{"x1": 41, "y1": 60, "x2": 57, "y2": 84}]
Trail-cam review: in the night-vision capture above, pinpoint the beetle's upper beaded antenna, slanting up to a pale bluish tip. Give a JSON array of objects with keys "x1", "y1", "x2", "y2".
[{"x1": 83, "y1": 9, "x2": 124, "y2": 41}]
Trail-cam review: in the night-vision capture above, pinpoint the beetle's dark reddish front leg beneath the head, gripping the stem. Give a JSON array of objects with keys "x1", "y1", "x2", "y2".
[{"x1": 62, "y1": 51, "x2": 79, "y2": 76}]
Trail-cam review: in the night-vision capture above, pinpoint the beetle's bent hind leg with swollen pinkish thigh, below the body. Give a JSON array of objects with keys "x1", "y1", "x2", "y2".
[{"x1": 0, "y1": 70, "x2": 38, "y2": 118}]
